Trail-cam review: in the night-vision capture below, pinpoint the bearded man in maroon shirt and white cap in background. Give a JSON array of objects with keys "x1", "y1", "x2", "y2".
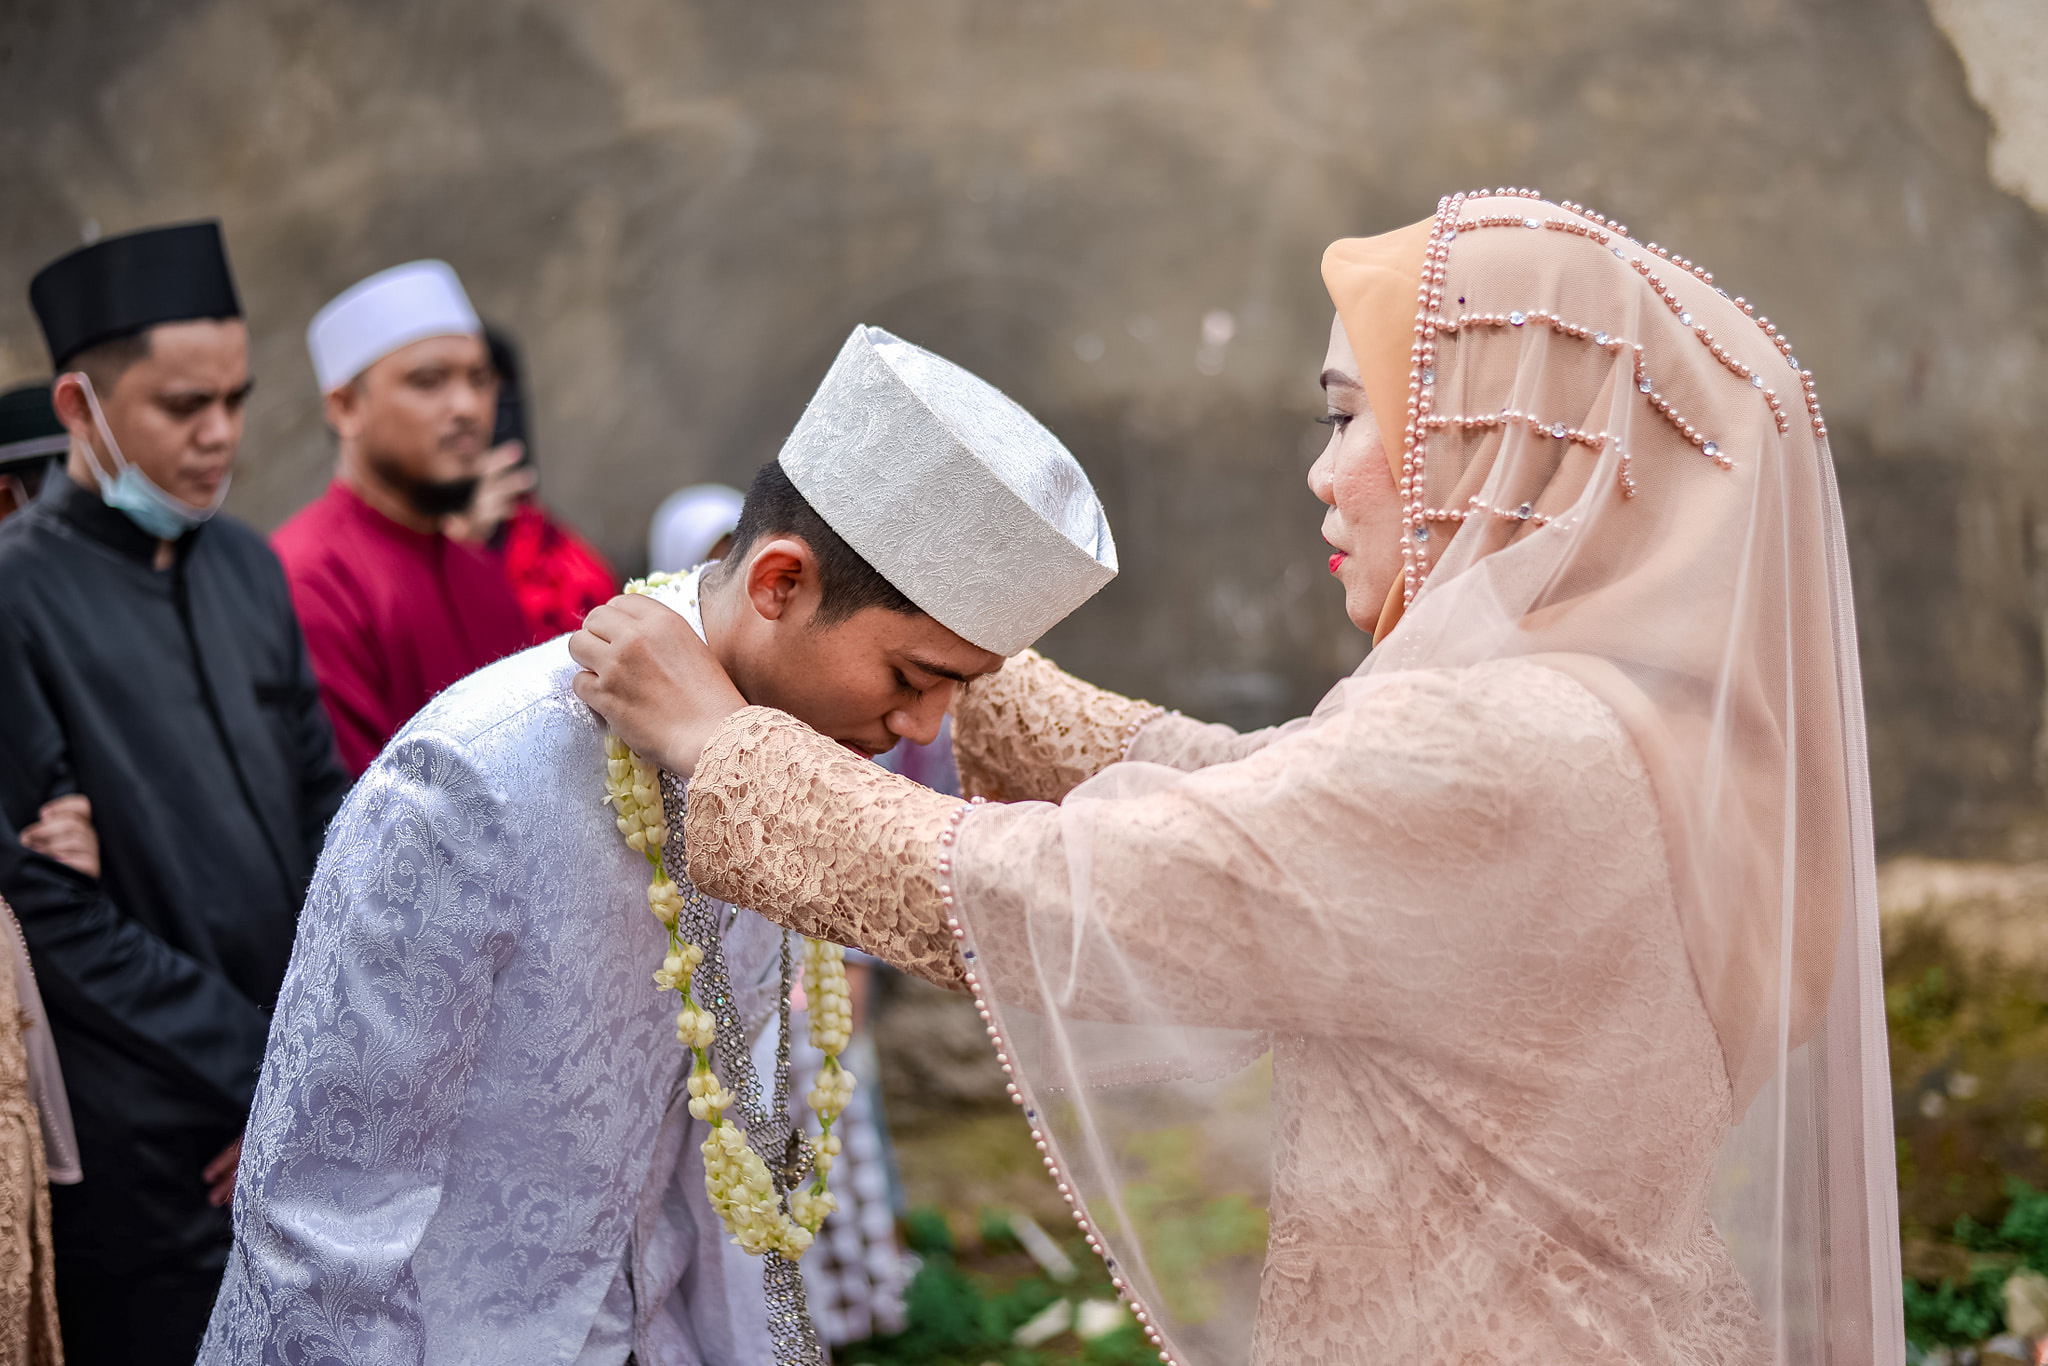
[{"x1": 270, "y1": 260, "x2": 530, "y2": 774}]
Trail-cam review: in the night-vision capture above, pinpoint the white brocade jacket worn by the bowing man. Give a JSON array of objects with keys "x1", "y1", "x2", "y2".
[{"x1": 199, "y1": 580, "x2": 780, "y2": 1366}]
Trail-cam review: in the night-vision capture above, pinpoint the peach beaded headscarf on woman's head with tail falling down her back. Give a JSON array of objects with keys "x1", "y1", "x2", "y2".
[{"x1": 1323, "y1": 190, "x2": 1898, "y2": 1360}]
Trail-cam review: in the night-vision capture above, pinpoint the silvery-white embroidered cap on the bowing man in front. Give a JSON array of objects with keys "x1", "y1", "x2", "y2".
[{"x1": 778, "y1": 326, "x2": 1116, "y2": 655}]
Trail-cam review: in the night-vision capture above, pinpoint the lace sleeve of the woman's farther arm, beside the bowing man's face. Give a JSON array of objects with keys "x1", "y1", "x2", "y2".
[{"x1": 952, "y1": 649, "x2": 1165, "y2": 801}]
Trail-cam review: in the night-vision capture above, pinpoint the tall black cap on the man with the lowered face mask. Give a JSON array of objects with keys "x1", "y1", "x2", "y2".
[{"x1": 29, "y1": 219, "x2": 242, "y2": 371}]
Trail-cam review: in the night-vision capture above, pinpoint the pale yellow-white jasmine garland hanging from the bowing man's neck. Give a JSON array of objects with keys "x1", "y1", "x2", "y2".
[{"x1": 604, "y1": 573, "x2": 854, "y2": 1262}]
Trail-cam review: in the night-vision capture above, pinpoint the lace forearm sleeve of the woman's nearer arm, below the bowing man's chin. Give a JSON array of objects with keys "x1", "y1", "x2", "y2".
[{"x1": 684, "y1": 707, "x2": 963, "y2": 987}]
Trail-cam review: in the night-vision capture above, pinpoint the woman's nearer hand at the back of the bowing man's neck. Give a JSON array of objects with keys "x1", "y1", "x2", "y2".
[{"x1": 569, "y1": 594, "x2": 748, "y2": 778}]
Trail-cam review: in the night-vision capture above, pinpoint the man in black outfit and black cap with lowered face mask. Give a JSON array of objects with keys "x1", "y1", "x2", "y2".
[{"x1": 0, "y1": 223, "x2": 348, "y2": 1364}]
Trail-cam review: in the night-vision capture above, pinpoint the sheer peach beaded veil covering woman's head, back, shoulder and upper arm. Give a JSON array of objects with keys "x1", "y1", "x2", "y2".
[{"x1": 952, "y1": 190, "x2": 1903, "y2": 1366}]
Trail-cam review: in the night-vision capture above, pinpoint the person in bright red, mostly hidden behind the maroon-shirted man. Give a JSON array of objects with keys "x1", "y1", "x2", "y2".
[{"x1": 446, "y1": 328, "x2": 618, "y2": 645}]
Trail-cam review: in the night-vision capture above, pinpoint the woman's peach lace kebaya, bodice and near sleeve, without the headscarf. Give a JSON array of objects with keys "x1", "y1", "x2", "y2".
[{"x1": 690, "y1": 661, "x2": 1769, "y2": 1366}]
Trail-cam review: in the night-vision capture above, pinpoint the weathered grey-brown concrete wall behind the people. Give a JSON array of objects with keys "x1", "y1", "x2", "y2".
[{"x1": 0, "y1": 0, "x2": 2048, "y2": 856}]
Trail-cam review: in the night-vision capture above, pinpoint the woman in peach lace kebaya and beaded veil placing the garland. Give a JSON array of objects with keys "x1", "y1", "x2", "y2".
[{"x1": 573, "y1": 190, "x2": 1903, "y2": 1364}]
